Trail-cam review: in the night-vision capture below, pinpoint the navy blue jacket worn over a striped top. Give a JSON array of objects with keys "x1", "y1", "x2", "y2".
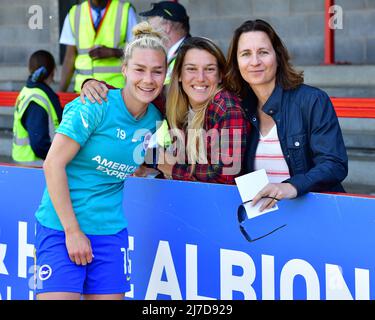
[{"x1": 243, "y1": 84, "x2": 348, "y2": 196}]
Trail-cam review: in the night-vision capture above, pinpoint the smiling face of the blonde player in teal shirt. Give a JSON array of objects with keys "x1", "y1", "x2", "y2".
[{"x1": 122, "y1": 48, "x2": 166, "y2": 108}]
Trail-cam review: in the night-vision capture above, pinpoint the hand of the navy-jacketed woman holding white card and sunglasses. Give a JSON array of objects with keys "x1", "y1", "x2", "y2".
[{"x1": 252, "y1": 183, "x2": 297, "y2": 211}]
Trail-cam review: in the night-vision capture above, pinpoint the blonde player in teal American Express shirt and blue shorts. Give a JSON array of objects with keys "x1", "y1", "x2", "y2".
[{"x1": 35, "y1": 22, "x2": 166, "y2": 299}]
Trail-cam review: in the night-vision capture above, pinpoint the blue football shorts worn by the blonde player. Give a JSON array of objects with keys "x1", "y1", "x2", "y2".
[{"x1": 34, "y1": 222, "x2": 130, "y2": 294}]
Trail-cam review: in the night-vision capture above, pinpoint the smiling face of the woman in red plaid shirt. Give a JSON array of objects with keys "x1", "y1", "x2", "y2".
[{"x1": 179, "y1": 49, "x2": 221, "y2": 109}]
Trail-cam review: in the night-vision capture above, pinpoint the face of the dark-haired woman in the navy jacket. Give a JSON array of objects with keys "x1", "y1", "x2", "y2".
[{"x1": 237, "y1": 31, "x2": 277, "y2": 91}]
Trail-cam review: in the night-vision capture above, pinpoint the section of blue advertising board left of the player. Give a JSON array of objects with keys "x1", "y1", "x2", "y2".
[{"x1": 0, "y1": 166, "x2": 45, "y2": 300}]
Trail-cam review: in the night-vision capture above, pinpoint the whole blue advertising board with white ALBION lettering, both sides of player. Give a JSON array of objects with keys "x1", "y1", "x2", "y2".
[{"x1": 0, "y1": 166, "x2": 375, "y2": 300}]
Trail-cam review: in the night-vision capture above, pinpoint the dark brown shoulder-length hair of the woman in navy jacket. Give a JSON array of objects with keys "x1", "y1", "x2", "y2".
[{"x1": 224, "y1": 19, "x2": 303, "y2": 97}]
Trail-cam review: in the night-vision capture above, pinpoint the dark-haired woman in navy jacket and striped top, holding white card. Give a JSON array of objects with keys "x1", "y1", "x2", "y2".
[{"x1": 226, "y1": 20, "x2": 348, "y2": 210}]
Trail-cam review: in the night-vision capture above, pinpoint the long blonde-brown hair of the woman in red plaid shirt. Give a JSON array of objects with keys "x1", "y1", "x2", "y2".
[{"x1": 166, "y1": 37, "x2": 226, "y2": 175}]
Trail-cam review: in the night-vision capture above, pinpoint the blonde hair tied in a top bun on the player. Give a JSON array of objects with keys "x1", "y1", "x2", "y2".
[{"x1": 123, "y1": 21, "x2": 167, "y2": 64}]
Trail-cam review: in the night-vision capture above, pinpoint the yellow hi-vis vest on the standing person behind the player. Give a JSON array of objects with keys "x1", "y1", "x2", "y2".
[{"x1": 69, "y1": 0, "x2": 130, "y2": 92}]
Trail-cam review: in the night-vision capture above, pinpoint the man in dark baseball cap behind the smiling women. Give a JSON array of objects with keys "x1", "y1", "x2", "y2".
[{"x1": 139, "y1": 1, "x2": 190, "y2": 84}]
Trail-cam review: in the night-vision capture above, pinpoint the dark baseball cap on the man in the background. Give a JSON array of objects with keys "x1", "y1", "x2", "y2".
[{"x1": 139, "y1": 1, "x2": 189, "y2": 23}]
